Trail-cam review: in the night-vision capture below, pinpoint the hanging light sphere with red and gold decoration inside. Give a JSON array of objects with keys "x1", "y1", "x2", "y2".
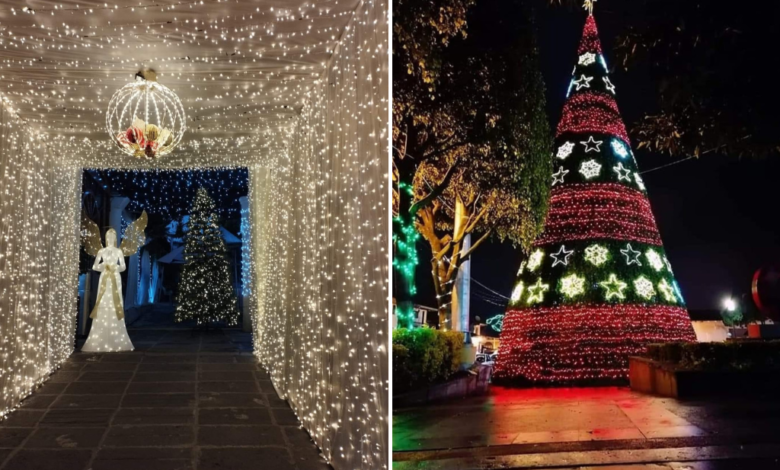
[{"x1": 106, "y1": 69, "x2": 187, "y2": 159}]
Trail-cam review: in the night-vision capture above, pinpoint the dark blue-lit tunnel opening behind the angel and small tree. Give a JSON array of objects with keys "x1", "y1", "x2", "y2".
[{"x1": 77, "y1": 168, "x2": 248, "y2": 338}]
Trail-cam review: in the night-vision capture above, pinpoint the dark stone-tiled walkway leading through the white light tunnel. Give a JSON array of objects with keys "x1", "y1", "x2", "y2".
[{"x1": 0, "y1": 330, "x2": 330, "y2": 470}]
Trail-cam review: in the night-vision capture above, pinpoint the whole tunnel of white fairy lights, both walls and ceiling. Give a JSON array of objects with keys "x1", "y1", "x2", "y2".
[{"x1": 0, "y1": 0, "x2": 390, "y2": 469}]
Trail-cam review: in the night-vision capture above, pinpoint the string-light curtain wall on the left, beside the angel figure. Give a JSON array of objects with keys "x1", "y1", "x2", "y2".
[{"x1": 0, "y1": 101, "x2": 80, "y2": 417}]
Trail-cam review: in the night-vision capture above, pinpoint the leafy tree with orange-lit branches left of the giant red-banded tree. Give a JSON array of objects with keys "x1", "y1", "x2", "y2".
[{"x1": 393, "y1": 2, "x2": 552, "y2": 327}]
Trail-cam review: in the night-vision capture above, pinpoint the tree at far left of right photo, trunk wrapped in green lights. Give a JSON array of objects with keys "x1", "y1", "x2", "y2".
[{"x1": 393, "y1": 0, "x2": 474, "y2": 328}]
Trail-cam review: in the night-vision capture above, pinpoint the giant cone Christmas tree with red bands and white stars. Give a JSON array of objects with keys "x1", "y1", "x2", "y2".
[{"x1": 495, "y1": 14, "x2": 695, "y2": 383}]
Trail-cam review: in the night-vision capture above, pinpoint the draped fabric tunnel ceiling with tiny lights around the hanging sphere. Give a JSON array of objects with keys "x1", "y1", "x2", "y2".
[{"x1": 0, "y1": 0, "x2": 359, "y2": 142}]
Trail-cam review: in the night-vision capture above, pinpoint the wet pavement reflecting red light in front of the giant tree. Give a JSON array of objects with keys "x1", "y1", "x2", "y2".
[{"x1": 393, "y1": 387, "x2": 780, "y2": 470}]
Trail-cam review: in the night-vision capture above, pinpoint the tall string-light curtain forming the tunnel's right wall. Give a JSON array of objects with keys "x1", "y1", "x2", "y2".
[{"x1": 252, "y1": 1, "x2": 389, "y2": 470}]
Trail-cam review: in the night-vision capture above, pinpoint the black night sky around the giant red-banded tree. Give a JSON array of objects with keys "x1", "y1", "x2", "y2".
[{"x1": 417, "y1": 0, "x2": 780, "y2": 320}]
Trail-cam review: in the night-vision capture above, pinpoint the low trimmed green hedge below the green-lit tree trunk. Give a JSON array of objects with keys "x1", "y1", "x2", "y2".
[{"x1": 393, "y1": 328, "x2": 463, "y2": 393}]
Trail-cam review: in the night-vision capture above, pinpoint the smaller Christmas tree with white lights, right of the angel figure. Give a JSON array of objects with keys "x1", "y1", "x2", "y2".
[{"x1": 176, "y1": 188, "x2": 238, "y2": 325}]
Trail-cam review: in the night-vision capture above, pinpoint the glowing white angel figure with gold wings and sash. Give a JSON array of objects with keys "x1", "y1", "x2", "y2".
[{"x1": 81, "y1": 211, "x2": 147, "y2": 352}]
